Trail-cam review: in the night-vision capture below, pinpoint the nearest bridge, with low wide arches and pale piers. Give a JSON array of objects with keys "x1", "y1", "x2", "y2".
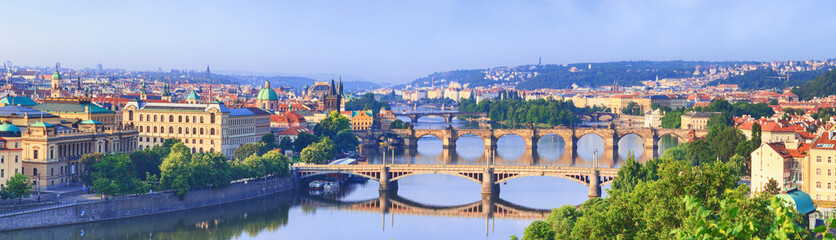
[{"x1": 291, "y1": 163, "x2": 618, "y2": 198}]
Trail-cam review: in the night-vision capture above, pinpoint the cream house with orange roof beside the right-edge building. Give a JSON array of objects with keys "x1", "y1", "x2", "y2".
[{"x1": 751, "y1": 142, "x2": 809, "y2": 192}]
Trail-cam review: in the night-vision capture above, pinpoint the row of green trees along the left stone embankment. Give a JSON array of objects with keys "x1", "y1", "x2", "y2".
[{"x1": 80, "y1": 134, "x2": 290, "y2": 200}]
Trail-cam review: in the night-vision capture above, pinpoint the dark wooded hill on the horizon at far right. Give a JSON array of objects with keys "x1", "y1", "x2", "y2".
[{"x1": 707, "y1": 69, "x2": 829, "y2": 89}]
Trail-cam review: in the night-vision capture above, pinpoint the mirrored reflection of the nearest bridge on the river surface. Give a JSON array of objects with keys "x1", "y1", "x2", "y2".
[{"x1": 301, "y1": 191, "x2": 551, "y2": 219}]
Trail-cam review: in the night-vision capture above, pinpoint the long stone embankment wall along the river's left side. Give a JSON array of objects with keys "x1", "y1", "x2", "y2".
[{"x1": 0, "y1": 177, "x2": 295, "y2": 231}]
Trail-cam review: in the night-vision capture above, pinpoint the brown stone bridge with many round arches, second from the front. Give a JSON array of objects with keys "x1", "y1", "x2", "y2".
[{"x1": 391, "y1": 127, "x2": 707, "y2": 158}]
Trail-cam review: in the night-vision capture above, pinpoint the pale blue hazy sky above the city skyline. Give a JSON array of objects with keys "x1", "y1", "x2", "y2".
[{"x1": 0, "y1": 0, "x2": 836, "y2": 83}]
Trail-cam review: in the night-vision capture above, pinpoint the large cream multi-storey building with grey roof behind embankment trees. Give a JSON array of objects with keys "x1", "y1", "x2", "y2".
[{"x1": 122, "y1": 100, "x2": 270, "y2": 156}]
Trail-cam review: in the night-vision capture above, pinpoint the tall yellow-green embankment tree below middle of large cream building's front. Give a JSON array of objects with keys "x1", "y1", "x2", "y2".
[{"x1": 160, "y1": 143, "x2": 192, "y2": 200}]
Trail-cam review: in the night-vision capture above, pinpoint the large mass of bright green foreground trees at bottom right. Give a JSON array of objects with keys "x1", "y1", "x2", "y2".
[{"x1": 512, "y1": 151, "x2": 811, "y2": 239}]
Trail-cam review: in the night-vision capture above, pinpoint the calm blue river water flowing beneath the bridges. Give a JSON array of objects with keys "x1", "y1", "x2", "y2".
[{"x1": 0, "y1": 114, "x2": 676, "y2": 239}]
